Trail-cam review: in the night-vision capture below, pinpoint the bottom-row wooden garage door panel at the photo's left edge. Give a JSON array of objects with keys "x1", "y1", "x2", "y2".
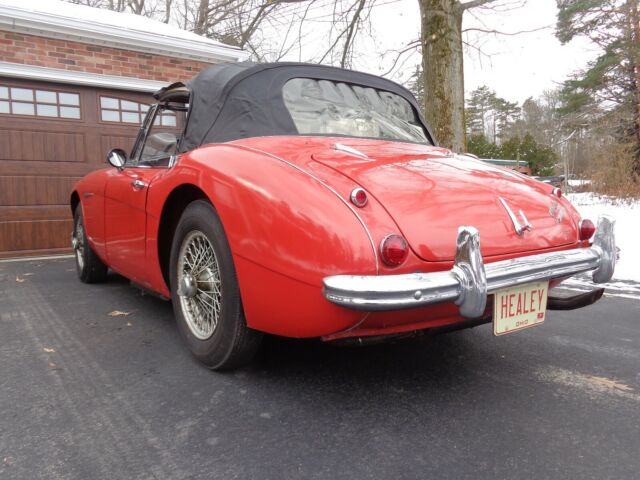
[{"x1": 0, "y1": 219, "x2": 73, "y2": 253}]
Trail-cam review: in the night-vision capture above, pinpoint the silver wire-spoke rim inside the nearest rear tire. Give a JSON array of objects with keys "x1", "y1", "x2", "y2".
[{"x1": 178, "y1": 230, "x2": 222, "y2": 340}]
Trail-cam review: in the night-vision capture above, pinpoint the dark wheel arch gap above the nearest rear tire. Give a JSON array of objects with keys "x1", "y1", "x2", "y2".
[{"x1": 157, "y1": 183, "x2": 213, "y2": 287}]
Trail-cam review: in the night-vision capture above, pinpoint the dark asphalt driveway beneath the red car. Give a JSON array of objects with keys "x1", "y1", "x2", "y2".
[{"x1": 0, "y1": 259, "x2": 640, "y2": 479}]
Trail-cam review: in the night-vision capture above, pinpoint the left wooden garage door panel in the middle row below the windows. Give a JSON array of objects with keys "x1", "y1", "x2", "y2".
[{"x1": 0, "y1": 176, "x2": 79, "y2": 206}]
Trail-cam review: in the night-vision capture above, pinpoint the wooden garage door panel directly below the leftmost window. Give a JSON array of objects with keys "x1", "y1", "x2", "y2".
[{"x1": 0, "y1": 128, "x2": 87, "y2": 162}]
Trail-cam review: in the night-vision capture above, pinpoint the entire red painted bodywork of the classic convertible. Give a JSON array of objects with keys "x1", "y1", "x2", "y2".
[{"x1": 76, "y1": 133, "x2": 581, "y2": 338}]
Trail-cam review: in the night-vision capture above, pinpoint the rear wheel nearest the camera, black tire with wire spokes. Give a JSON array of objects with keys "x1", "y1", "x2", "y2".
[{"x1": 170, "y1": 200, "x2": 263, "y2": 370}]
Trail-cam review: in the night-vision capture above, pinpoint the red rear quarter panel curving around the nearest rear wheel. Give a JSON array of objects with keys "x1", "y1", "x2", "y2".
[{"x1": 147, "y1": 145, "x2": 376, "y2": 337}]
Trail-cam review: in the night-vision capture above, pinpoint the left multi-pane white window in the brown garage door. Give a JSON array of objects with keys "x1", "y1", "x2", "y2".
[{"x1": 0, "y1": 85, "x2": 81, "y2": 120}]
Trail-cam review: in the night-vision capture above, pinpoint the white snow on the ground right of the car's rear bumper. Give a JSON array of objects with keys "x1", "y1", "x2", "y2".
[{"x1": 562, "y1": 193, "x2": 640, "y2": 299}]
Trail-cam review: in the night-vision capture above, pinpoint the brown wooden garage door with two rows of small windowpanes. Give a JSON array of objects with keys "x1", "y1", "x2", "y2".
[{"x1": 0, "y1": 77, "x2": 152, "y2": 258}]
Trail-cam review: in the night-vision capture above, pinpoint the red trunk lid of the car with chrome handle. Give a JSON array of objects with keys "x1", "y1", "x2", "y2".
[{"x1": 312, "y1": 140, "x2": 578, "y2": 261}]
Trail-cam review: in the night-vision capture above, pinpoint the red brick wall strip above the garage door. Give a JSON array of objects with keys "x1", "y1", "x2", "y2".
[{"x1": 0, "y1": 31, "x2": 208, "y2": 81}]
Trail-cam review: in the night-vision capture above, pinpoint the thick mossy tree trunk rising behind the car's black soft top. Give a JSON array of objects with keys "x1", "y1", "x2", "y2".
[{"x1": 418, "y1": 0, "x2": 465, "y2": 152}]
